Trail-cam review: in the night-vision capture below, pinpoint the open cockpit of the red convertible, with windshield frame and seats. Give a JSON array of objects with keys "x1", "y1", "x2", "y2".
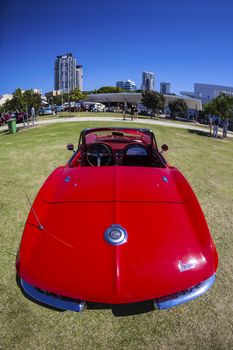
[{"x1": 69, "y1": 128, "x2": 166, "y2": 168}]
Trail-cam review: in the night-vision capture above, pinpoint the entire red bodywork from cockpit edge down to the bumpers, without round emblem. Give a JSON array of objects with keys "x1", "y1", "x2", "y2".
[{"x1": 17, "y1": 127, "x2": 218, "y2": 304}]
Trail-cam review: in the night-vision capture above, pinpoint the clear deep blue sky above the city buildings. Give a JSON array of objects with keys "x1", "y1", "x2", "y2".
[{"x1": 0, "y1": 0, "x2": 233, "y2": 94}]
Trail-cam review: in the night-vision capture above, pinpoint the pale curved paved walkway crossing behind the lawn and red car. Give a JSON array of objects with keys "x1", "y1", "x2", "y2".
[{"x1": 0, "y1": 116, "x2": 233, "y2": 137}]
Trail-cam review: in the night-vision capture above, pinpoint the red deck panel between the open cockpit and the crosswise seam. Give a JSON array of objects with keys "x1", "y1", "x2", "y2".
[{"x1": 41, "y1": 166, "x2": 191, "y2": 203}]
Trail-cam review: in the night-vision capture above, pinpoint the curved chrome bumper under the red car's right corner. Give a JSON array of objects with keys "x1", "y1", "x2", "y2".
[{"x1": 153, "y1": 274, "x2": 215, "y2": 310}]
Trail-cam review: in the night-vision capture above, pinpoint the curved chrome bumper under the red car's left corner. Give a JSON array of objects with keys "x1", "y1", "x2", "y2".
[{"x1": 20, "y1": 278, "x2": 86, "y2": 312}]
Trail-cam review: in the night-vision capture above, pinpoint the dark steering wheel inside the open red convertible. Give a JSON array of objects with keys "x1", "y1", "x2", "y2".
[{"x1": 86, "y1": 143, "x2": 112, "y2": 166}]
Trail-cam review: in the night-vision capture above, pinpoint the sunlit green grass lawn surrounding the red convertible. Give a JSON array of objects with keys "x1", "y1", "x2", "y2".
[{"x1": 0, "y1": 122, "x2": 233, "y2": 350}]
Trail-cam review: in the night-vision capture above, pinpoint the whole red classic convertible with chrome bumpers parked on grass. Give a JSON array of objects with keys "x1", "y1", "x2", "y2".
[{"x1": 16, "y1": 127, "x2": 218, "y2": 311}]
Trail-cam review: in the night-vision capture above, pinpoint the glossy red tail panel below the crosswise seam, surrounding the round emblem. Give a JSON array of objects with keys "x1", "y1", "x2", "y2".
[{"x1": 20, "y1": 197, "x2": 217, "y2": 303}]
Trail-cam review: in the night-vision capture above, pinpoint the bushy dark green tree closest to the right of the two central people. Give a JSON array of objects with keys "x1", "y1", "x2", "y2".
[{"x1": 142, "y1": 91, "x2": 165, "y2": 118}]
